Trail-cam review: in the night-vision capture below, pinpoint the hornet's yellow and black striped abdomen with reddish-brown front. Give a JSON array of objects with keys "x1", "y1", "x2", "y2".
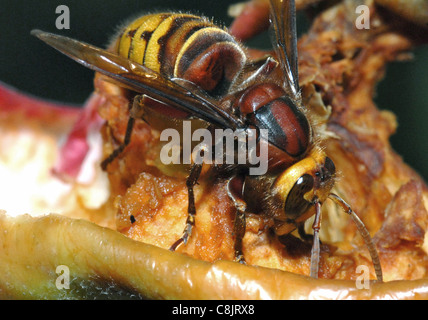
[{"x1": 116, "y1": 13, "x2": 246, "y2": 96}]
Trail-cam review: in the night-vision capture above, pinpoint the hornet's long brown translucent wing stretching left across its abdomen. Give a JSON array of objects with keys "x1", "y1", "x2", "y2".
[{"x1": 31, "y1": 30, "x2": 241, "y2": 129}]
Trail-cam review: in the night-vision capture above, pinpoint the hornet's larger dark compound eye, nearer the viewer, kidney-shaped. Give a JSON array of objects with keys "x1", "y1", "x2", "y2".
[{"x1": 284, "y1": 174, "x2": 314, "y2": 220}]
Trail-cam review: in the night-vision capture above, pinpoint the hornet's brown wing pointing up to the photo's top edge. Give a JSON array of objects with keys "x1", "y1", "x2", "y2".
[{"x1": 270, "y1": 0, "x2": 300, "y2": 99}]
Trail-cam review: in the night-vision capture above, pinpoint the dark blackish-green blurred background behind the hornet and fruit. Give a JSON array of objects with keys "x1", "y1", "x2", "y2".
[{"x1": 0, "y1": 0, "x2": 428, "y2": 181}]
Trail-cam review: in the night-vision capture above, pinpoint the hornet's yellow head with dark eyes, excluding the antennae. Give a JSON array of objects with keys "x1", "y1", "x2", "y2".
[{"x1": 273, "y1": 148, "x2": 335, "y2": 234}]
